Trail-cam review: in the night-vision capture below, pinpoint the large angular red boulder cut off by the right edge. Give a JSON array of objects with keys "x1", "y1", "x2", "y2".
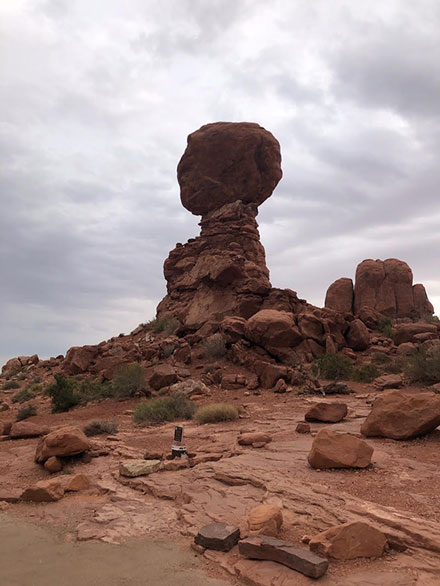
[{"x1": 361, "y1": 390, "x2": 440, "y2": 440}]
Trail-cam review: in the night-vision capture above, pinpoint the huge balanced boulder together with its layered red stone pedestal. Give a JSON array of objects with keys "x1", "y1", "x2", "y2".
[{"x1": 158, "y1": 122, "x2": 282, "y2": 329}]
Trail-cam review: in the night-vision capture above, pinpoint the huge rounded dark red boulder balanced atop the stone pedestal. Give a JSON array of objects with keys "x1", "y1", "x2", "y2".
[{"x1": 177, "y1": 122, "x2": 282, "y2": 215}]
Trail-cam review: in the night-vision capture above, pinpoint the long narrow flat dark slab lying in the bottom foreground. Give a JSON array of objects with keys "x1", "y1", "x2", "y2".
[{"x1": 238, "y1": 535, "x2": 328, "y2": 578}]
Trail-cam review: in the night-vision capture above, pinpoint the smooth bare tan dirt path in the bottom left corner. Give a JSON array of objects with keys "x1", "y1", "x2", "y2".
[{"x1": 0, "y1": 513, "x2": 235, "y2": 586}]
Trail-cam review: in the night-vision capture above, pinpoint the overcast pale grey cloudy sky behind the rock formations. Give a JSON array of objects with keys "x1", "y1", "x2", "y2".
[{"x1": 0, "y1": 0, "x2": 440, "y2": 364}]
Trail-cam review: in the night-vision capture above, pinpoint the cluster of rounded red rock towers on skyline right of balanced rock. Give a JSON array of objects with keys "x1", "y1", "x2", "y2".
[{"x1": 325, "y1": 258, "x2": 434, "y2": 318}]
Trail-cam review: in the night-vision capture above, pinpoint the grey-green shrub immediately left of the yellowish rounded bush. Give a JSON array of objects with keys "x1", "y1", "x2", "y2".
[{"x1": 133, "y1": 393, "x2": 195, "y2": 423}]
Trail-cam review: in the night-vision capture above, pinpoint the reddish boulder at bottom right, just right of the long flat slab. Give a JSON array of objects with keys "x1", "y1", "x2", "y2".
[{"x1": 309, "y1": 521, "x2": 387, "y2": 560}]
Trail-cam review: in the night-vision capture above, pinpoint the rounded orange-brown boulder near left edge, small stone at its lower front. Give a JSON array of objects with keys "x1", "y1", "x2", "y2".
[{"x1": 35, "y1": 427, "x2": 90, "y2": 462}]
